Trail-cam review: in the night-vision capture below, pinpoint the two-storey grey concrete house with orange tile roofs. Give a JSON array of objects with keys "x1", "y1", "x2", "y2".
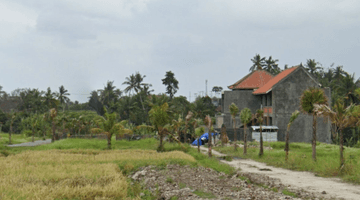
[{"x1": 217, "y1": 66, "x2": 331, "y2": 143}]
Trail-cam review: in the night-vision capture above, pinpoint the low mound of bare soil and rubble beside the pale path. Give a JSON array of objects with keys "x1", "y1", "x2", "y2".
[{"x1": 129, "y1": 165, "x2": 327, "y2": 200}]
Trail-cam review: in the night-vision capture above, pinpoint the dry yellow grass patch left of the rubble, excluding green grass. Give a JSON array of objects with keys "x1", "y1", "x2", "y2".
[{"x1": 0, "y1": 150, "x2": 195, "y2": 199}]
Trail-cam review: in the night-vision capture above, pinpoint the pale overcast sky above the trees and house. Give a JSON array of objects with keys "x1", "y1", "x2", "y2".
[{"x1": 0, "y1": 0, "x2": 360, "y2": 103}]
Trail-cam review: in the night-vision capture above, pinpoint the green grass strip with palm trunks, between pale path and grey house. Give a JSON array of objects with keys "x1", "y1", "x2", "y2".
[{"x1": 215, "y1": 142, "x2": 360, "y2": 184}]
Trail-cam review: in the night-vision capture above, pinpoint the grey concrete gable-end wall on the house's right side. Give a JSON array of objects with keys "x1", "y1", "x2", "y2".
[{"x1": 272, "y1": 68, "x2": 331, "y2": 143}]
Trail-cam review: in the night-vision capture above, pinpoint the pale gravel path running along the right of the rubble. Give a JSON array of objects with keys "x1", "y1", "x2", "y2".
[{"x1": 193, "y1": 147, "x2": 360, "y2": 200}]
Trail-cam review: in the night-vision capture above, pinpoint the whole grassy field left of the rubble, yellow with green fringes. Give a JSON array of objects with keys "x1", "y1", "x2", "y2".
[{"x1": 0, "y1": 139, "x2": 234, "y2": 199}]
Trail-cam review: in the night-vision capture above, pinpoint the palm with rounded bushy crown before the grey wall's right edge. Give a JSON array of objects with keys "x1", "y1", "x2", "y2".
[{"x1": 300, "y1": 87, "x2": 328, "y2": 161}]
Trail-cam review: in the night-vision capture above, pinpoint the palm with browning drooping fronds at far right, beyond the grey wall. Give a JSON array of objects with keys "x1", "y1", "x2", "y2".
[{"x1": 314, "y1": 99, "x2": 360, "y2": 168}]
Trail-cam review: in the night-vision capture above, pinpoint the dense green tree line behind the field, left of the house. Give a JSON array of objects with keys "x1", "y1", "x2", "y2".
[{"x1": 0, "y1": 71, "x2": 216, "y2": 144}]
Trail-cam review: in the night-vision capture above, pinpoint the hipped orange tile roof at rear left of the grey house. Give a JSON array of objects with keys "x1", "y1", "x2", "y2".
[{"x1": 228, "y1": 70, "x2": 273, "y2": 89}]
